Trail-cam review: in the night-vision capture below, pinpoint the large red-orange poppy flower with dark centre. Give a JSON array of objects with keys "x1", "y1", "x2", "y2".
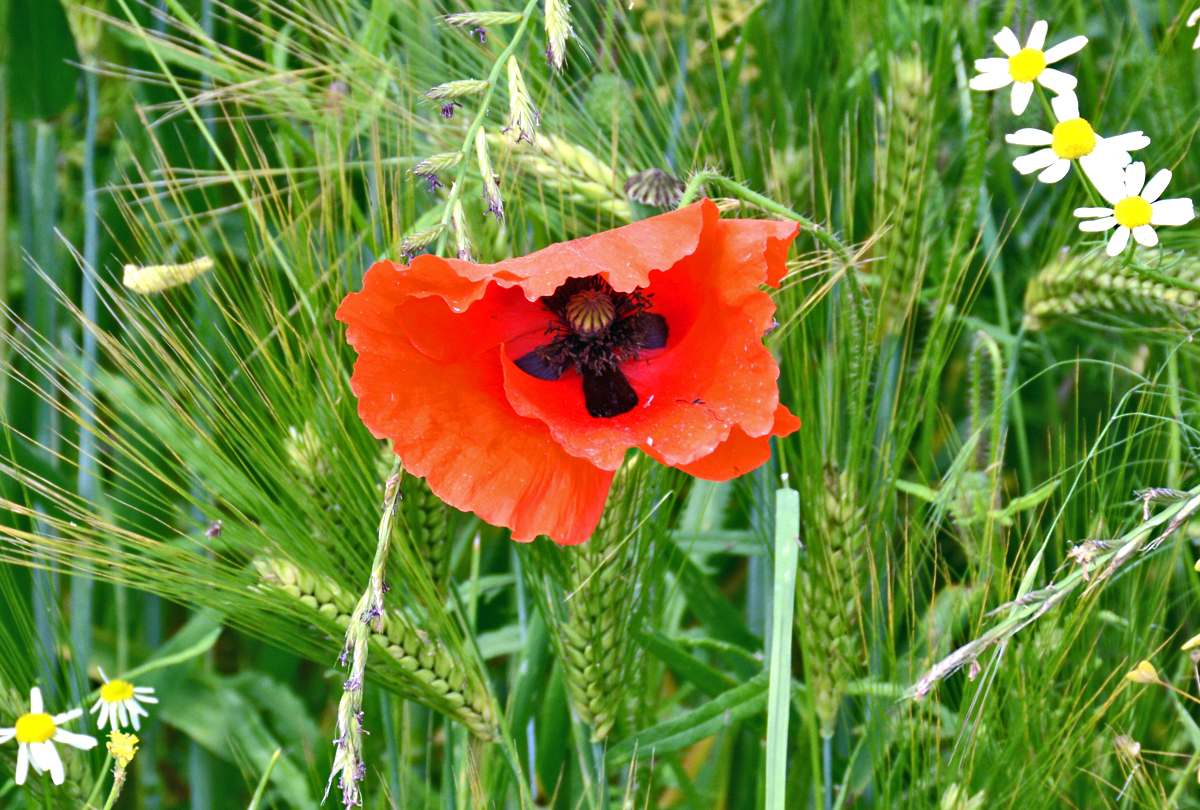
[{"x1": 337, "y1": 200, "x2": 799, "y2": 545}]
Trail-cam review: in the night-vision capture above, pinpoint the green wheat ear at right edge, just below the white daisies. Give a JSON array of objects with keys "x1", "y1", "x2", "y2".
[{"x1": 1025, "y1": 248, "x2": 1200, "y2": 331}]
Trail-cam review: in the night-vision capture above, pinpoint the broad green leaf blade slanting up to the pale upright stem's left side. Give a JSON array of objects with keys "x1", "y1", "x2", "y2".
[{"x1": 608, "y1": 672, "x2": 768, "y2": 764}]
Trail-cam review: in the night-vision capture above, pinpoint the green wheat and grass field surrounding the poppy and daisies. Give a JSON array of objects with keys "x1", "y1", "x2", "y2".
[{"x1": 0, "y1": 0, "x2": 1200, "y2": 810}]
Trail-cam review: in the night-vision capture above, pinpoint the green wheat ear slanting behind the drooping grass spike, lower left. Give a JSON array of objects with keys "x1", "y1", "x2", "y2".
[{"x1": 253, "y1": 558, "x2": 498, "y2": 740}]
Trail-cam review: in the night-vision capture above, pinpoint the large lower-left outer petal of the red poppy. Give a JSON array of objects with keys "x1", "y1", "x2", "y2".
[{"x1": 337, "y1": 262, "x2": 612, "y2": 545}]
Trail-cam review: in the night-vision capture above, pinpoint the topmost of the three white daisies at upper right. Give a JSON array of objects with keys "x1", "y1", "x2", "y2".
[{"x1": 971, "y1": 19, "x2": 1087, "y2": 115}]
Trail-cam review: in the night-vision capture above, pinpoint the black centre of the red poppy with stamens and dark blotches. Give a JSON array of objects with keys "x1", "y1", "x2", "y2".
[{"x1": 516, "y1": 276, "x2": 667, "y2": 419}]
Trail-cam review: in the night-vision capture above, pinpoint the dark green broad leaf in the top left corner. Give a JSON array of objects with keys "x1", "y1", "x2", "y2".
[{"x1": 5, "y1": 0, "x2": 79, "y2": 121}]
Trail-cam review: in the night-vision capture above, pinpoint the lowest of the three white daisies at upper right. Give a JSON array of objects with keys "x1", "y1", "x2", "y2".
[{"x1": 1075, "y1": 161, "x2": 1195, "y2": 256}]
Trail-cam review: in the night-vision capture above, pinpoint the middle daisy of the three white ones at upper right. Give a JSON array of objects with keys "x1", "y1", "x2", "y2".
[{"x1": 1004, "y1": 94, "x2": 1150, "y2": 186}]
